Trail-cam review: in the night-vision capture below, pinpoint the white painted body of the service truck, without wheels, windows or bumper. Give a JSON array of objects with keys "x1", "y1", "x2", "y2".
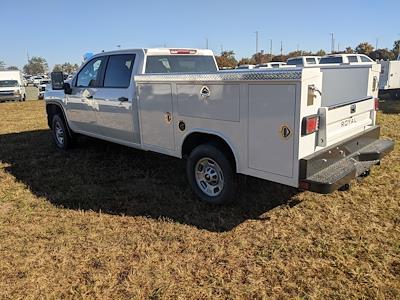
[{"x1": 45, "y1": 49, "x2": 394, "y2": 197}]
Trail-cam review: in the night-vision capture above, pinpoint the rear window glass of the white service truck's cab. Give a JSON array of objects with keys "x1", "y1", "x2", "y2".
[{"x1": 146, "y1": 55, "x2": 217, "y2": 74}]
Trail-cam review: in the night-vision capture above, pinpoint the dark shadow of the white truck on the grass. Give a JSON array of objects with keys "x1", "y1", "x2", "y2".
[{"x1": 0, "y1": 130, "x2": 298, "y2": 232}]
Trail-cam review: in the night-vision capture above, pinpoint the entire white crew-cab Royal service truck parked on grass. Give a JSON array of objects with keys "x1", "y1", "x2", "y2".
[{"x1": 45, "y1": 49, "x2": 394, "y2": 204}]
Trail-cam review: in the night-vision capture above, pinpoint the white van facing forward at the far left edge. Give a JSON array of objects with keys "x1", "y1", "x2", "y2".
[{"x1": 0, "y1": 71, "x2": 26, "y2": 102}]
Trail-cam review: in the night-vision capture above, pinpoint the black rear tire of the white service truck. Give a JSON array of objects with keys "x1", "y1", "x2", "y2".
[{"x1": 186, "y1": 144, "x2": 237, "y2": 204}]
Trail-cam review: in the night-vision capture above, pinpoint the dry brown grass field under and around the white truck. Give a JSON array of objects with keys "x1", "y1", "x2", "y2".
[{"x1": 0, "y1": 101, "x2": 400, "y2": 299}]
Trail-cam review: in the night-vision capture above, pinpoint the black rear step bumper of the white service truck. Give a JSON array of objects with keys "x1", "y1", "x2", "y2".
[{"x1": 299, "y1": 126, "x2": 394, "y2": 194}]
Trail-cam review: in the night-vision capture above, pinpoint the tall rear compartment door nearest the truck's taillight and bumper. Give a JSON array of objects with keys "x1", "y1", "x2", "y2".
[{"x1": 248, "y1": 84, "x2": 296, "y2": 178}]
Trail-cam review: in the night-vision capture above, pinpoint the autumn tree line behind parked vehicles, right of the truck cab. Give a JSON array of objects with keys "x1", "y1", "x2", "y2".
[{"x1": 215, "y1": 40, "x2": 400, "y2": 68}]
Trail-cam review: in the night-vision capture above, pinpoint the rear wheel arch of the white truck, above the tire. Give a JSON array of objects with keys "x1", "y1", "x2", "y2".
[{"x1": 181, "y1": 130, "x2": 238, "y2": 171}]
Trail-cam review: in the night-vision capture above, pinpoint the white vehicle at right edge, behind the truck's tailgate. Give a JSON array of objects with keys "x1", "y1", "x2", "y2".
[{"x1": 379, "y1": 60, "x2": 400, "y2": 98}]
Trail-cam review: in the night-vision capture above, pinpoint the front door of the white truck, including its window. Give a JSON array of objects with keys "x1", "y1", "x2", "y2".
[{"x1": 66, "y1": 57, "x2": 105, "y2": 134}]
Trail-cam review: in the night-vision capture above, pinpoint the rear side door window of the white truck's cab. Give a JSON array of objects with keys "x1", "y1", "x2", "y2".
[{"x1": 104, "y1": 54, "x2": 135, "y2": 88}]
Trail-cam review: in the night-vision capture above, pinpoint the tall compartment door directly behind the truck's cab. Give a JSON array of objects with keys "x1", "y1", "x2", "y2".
[{"x1": 138, "y1": 83, "x2": 175, "y2": 150}]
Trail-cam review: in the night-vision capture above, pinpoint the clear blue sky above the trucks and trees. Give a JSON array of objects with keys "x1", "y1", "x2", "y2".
[{"x1": 0, "y1": 0, "x2": 400, "y2": 67}]
